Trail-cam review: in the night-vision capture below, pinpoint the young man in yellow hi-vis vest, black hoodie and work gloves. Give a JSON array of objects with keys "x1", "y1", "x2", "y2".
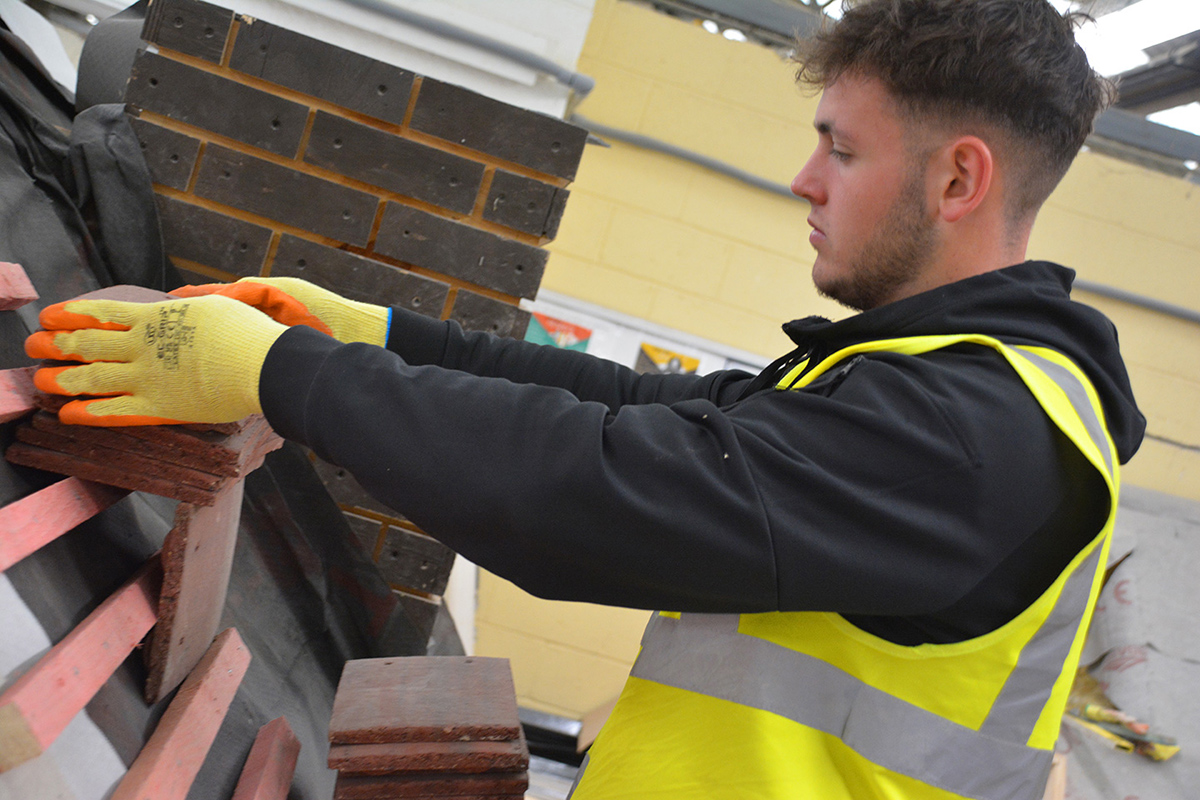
[{"x1": 29, "y1": 0, "x2": 1145, "y2": 800}]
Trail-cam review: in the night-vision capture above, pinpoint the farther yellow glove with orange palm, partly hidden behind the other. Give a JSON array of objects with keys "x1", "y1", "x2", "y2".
[{"x1": 172, "y1": 278, "x2": 391, "y2": 347}]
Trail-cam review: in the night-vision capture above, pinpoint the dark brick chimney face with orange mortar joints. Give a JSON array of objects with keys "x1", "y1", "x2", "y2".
[{"x1": 126, "y1": 0, "x2": 587, "y2": 606}]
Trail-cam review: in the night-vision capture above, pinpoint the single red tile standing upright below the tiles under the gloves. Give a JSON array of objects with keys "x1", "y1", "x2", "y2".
[{"x1": 145, "y1": 480, "x2": 245, "y2": 704}]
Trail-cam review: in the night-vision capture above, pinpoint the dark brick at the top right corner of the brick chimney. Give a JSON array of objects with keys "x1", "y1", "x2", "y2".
[{"x1": 409, "y1": 78, "x2": 588, "y2": 180}]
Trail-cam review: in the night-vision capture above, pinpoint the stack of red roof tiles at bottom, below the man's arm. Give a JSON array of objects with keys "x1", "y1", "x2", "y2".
[{"x1": 329, "y1": 656, "x2": 529, "y2": 800}]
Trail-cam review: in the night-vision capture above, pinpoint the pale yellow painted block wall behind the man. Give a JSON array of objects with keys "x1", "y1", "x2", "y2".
[{"x1": 476, "y1": 0, "x2": 1200, "y2": 717}]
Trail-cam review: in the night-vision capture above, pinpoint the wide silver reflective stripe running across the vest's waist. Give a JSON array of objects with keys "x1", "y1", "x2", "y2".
[{"x1": 631, "y1": 614, "x2": 1052, "y2": 800}]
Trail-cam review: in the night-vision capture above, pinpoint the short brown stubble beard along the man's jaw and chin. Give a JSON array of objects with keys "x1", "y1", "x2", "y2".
[{"x1": 816, "y1": 178, "x2": 936, "y2": 311}]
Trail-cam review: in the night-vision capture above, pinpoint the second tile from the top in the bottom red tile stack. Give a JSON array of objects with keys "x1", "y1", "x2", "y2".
[{"x1": 329, "y1": 738, "x2": 529, "y2": 775}]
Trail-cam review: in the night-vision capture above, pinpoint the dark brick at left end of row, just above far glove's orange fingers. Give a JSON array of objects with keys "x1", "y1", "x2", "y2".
[{"x1": 155, "y1": 194, "x2": 272, "y2": 275}]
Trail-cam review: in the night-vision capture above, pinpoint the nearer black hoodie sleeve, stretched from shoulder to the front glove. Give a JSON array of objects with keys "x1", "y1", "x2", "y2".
[{"x1": 260, "y1": 327, "x2": 1075, "y2": 614}]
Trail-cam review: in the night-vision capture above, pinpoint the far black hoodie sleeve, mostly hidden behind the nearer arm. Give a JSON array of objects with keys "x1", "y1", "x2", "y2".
[{"x1": 388, "y1": 303, "x2": 751, "y2": 411}]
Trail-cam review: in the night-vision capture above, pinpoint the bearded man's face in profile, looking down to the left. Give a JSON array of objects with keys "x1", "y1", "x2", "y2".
[{"x1": 792, "y1": 74, "x2": 937, "y2": 311}]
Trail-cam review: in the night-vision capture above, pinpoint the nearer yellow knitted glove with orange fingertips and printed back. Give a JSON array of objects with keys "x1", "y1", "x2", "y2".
[{"x1": 25, "y1": 297, "x2": 287, "y2": 426}]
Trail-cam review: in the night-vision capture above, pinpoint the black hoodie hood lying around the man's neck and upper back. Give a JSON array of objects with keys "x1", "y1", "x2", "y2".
[{"x1": 784, "y1": 261, "x2": 1146, "y2": 464}]
